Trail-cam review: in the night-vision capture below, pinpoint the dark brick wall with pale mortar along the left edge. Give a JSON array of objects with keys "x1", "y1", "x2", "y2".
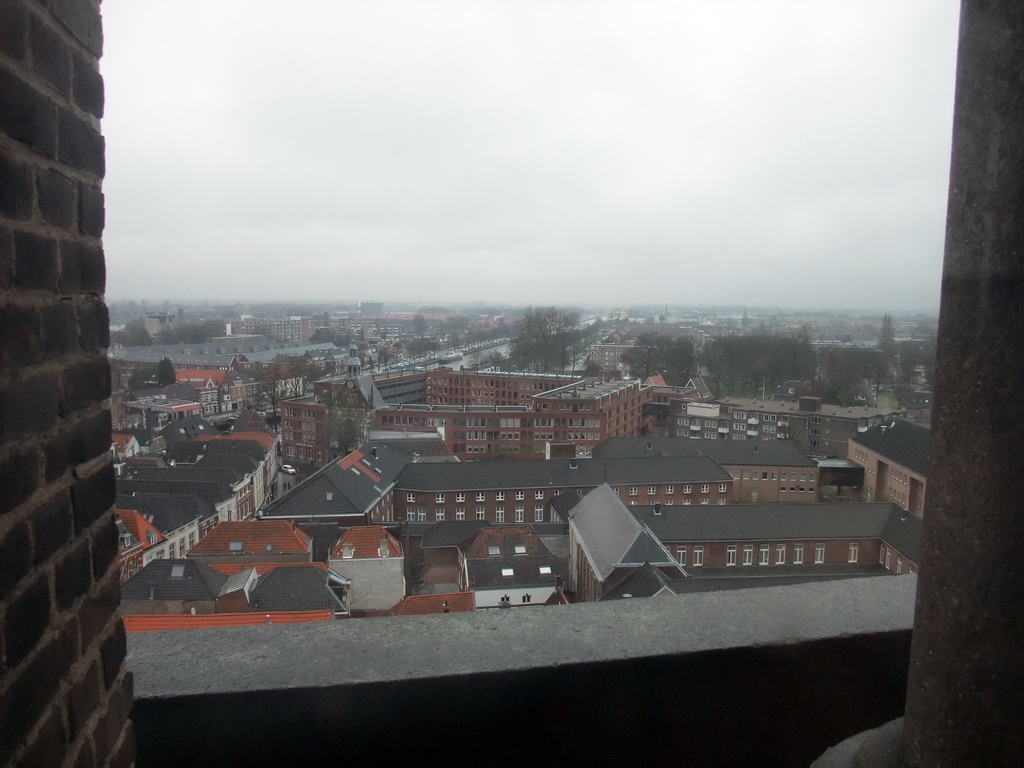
[{"x1": 0, "y1": 0, "x2": 134, "y2": 766}]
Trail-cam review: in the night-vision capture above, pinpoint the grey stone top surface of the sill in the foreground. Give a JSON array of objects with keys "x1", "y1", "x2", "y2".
[{"x1": 127, "y1": 575, "x2": 918, "y2": 700}]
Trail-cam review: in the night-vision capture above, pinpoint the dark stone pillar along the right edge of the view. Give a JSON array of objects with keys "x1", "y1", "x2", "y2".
[{"x1": 904, "y1": 0, "x2": 1024, "y2": 768}]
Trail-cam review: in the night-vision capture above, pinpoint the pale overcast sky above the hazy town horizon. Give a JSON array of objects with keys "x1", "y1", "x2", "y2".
[{"x1": 101, "y1": 0, "x2": 958, "y2": 311}]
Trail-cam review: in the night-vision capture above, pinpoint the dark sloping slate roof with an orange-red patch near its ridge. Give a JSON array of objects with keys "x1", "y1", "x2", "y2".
[{"x1": 262, "y1": 443, "x2": 411, "y2": 519}]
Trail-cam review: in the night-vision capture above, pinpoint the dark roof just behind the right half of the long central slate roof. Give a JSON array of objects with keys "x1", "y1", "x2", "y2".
[{"x1": 594, "y1": 437, "x2": 814, "y2": 467}]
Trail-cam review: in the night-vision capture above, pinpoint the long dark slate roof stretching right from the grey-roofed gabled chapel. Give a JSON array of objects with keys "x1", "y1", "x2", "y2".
[{"x1": 629, "y1": 502, "x2": 921, "y2": 562}]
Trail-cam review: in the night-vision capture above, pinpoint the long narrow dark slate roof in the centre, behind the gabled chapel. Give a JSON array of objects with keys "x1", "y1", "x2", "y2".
[{"x1": 398, "y1": 456, "x2": 732, "y2": 492}]
